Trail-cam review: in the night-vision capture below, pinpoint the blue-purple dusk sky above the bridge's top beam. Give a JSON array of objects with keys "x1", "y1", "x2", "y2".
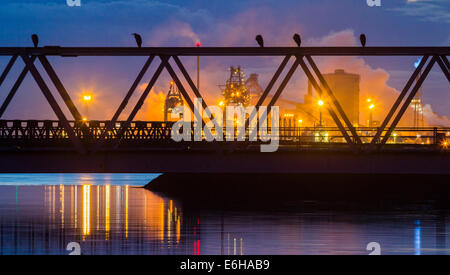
[{"x1": 0, "y1": 0, "x2": 450, "y2": 46}]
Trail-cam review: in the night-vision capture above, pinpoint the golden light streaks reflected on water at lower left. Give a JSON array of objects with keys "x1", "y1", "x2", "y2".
[{"x1": 0, "y1": 184, "x2": 184, "y2": 254}]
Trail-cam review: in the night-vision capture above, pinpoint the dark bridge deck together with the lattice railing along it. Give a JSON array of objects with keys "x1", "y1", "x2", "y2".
[{"x1": 0, "y1": 120, "x2": 450, "y2": 174}]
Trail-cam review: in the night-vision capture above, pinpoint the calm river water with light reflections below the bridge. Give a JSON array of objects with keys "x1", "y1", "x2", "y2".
[{"x1": 0, "y1": 174, "x2": 450, "y2": 255}]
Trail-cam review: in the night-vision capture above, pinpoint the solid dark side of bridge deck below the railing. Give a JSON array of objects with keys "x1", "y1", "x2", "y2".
[{"x1": 0, "y1": 147, "x2": 450, "y2": 174}]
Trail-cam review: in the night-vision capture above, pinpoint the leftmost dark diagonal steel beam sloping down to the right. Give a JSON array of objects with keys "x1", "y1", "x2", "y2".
[{"x1": 21, "y1": 55, "x2": 85, "y2": 153}]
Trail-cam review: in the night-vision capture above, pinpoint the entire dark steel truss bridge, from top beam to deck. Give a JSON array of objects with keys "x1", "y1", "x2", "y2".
[{"x1": 0, "y1": 46, "x2": 450, "y2": 174}]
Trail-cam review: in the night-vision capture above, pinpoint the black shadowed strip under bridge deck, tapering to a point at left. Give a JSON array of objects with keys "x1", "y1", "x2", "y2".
[{"x1": 144, "y1": 174, "x2": 450, "y2": 212}]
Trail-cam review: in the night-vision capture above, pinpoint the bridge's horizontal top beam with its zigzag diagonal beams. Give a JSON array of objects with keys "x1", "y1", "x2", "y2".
[{"x1": 0, "y1": 46, "x2": 450, "y2": 153}]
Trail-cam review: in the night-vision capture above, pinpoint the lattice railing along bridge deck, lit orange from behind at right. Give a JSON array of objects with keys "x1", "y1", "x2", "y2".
[{"x1": 0, "y1": 120, "x2": 450, "y2": 145}]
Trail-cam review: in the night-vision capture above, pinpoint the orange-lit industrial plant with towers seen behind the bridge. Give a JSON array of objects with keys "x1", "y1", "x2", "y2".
[{"x1": 164, "y1": 65, "x2": 425, "y2": 132}]
